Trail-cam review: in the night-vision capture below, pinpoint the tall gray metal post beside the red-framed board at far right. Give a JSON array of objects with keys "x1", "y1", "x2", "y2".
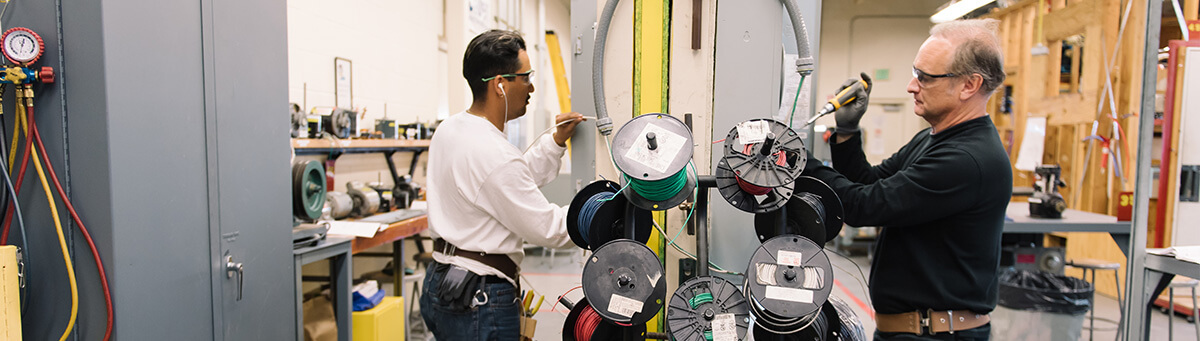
[{"x1": 1124, "y1": 1, "x2": 1163, "y2": 340}]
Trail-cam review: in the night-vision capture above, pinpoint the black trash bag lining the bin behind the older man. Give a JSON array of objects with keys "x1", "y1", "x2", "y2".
[{"x1": 1000, "y1": 269, "x2": 1096, "y2": 316}]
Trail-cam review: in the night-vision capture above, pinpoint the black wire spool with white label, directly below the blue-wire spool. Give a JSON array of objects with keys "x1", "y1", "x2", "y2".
[{"x1": 583, "y1": 239, "x2": 667, "y2": 325}]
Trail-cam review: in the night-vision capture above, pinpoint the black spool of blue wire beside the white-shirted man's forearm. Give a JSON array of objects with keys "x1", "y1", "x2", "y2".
[{"x1": 566, "y1": 180, "x2": 653, "y2": 250}]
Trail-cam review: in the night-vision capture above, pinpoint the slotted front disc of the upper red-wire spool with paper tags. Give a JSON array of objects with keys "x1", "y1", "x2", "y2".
[{"x1": 721, "y1": 119, "x2": 808, "y2": 192}]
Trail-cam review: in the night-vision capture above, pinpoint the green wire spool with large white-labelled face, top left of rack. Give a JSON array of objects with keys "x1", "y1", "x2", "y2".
[{"x1": 612, "y1": 113, "x2": 696, "y2": 210}]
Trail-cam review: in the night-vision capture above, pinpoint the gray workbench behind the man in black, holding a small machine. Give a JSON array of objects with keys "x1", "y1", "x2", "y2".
[{"x1": 1004, "y1": 202, "x2": 1130, "y2": 258}]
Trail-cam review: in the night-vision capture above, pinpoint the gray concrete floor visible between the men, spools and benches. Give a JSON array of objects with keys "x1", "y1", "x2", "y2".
[{"x1": 403, "y1": 249, "x2": 1200, "y2": 341}]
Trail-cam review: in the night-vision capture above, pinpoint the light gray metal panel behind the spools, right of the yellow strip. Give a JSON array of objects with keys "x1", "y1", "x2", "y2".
[{"x1": 708, "y1": 0, "x2": 821, "y2": 279}]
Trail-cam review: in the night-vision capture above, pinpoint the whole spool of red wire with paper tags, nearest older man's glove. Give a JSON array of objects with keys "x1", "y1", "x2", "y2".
[{"x1": 713, "y1": 119, "x2": 808, "y2": 214}]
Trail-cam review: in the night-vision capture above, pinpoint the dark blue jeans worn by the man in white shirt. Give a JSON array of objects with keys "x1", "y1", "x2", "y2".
[{"x1": 420, "y1": 262, "x2": 521, "y2": 341}]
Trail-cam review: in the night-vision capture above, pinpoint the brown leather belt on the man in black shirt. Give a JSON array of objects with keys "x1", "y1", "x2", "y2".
[{"x1": 875, "y1": 310, "x2": 991, "y2": 335}]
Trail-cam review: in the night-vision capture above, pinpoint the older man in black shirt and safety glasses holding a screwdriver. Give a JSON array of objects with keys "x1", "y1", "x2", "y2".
[{"x1": 804, "y1": 19, "x2": 1013, "y2": 340}]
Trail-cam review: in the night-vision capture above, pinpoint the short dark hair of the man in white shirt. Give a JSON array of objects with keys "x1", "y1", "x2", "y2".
[{"x1": 462, "y1": 30, "x2": 526, "y2": 100}]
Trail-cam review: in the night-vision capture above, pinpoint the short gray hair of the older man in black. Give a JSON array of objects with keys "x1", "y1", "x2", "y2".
[{"x1": 929, "y1": 19, "x2": 1004, "y2": 96}]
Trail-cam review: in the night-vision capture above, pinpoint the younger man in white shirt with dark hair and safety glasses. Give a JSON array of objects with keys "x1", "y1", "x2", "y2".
[{"x1": 420, "y1": 30, "x2": 583, "y2": 340}]
